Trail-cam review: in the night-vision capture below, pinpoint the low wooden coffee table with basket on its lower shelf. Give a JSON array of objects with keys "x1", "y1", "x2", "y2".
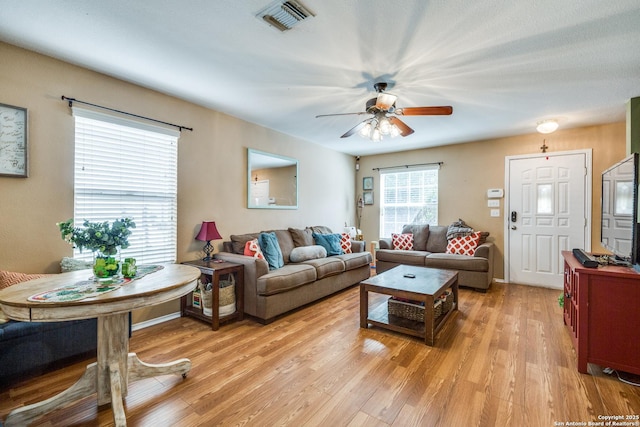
[{"x1": 360, "y1": 265, "x2": 458, "y2": 346}]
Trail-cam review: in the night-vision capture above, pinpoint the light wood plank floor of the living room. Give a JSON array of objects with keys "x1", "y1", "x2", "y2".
[{"x1": 0, "y1": 284, "x2": 640, "y2": 426}]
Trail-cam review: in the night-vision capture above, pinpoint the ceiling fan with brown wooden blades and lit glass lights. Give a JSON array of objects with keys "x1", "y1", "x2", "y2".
[{"x1": 316, "y1": 82, "x2": 453, "y2": 141}]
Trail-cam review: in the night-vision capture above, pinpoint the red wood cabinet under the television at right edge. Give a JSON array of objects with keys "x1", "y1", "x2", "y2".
[{"x1": 562, "y1": 251, "x2": 640, "y2": 375}]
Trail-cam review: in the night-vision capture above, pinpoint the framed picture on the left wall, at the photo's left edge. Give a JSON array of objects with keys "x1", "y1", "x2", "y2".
[{"x1": 0, "y1": 104, "x2": 28, "y2": 178}]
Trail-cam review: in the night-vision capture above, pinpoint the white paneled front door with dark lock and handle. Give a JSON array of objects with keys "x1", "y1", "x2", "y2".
[{"x1": 505, "y1": 150, "x2": 591, "y2": 289}]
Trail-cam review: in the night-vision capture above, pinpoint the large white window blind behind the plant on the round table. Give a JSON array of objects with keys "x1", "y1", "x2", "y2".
[{"x1": 73, "y1": 107, "x2": 180, "y2": 264}]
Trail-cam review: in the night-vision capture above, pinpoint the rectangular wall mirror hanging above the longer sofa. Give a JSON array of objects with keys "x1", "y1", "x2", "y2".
[{"x1": 247, "y1": 148, "x2": 298, "y2": 209}]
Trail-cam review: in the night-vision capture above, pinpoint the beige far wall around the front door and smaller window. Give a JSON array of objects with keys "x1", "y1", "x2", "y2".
[{"x1": 356, "y1": 123, "x2": 626, "y2": 278}]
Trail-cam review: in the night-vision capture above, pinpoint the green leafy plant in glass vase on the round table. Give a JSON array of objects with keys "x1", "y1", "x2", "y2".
[{"x1": 56, "y1": 218, "x2": 136, "y2": 279}]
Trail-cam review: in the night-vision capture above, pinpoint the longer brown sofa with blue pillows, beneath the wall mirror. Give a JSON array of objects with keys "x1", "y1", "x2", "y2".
[{"x1": 215, "y1": 227, "x2": 372, "y2": 323}]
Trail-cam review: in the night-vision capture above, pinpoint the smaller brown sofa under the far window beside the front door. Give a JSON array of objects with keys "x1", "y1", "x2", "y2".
[{"x1": 376, "y1": 224, "x2": 494, "y2": 292}]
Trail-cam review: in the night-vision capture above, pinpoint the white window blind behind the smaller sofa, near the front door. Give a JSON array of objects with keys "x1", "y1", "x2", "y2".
[{"x1": 380, "y1": 165, "x2": 439, "y2": 238}]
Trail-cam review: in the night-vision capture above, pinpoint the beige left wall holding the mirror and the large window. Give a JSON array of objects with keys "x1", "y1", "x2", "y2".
[{"x1": 0, "y1": 43, "x2": 355, "y2": 321}]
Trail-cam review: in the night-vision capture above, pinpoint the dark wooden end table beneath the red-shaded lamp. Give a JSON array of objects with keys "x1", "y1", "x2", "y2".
[{"x1": 180, "y1": 260, "x2": 244, "y2": 331}]
